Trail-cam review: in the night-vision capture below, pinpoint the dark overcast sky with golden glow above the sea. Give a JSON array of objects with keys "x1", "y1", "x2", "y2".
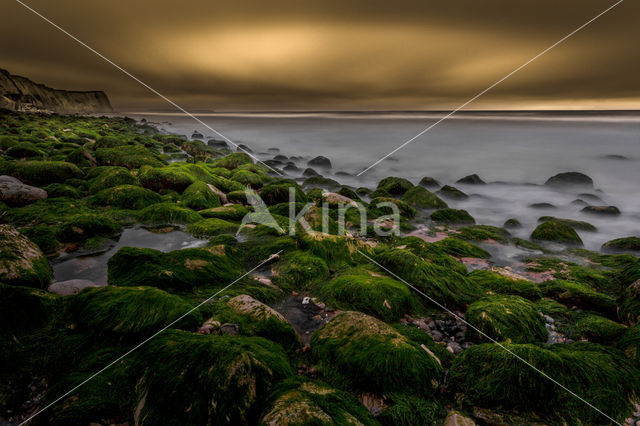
[{"x1": 0, "y1": 0, "x2": 640, "y2": 111}]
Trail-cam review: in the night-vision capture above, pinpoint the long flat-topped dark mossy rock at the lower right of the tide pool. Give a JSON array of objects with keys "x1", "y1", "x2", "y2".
[{"x1": 108, "y1": 247, "x2": 242, "y2": 291}]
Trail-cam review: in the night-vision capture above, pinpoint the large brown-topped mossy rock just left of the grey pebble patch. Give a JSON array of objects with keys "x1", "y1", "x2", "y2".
[{"x1": 311, "y1": 311, "x2": 442, "y2": 395}]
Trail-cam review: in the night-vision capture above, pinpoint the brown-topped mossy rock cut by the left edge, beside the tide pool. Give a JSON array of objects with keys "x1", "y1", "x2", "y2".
[{"x1": 0, "y1": 225, "x2": 53, "y2": 288}]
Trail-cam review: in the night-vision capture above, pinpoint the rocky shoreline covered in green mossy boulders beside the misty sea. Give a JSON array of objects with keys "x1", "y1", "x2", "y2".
[{"x1": 0, "y1": 111, "x2": 640, "y2": 425}]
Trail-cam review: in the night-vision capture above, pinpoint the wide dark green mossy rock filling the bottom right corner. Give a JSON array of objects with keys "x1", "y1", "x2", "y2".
[{"x1": 449, "y1": 342, "x2": 640, "y2": 424}]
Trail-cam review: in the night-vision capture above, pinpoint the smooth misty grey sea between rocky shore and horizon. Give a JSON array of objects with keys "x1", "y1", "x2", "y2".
[{"x1": 132, "y1": 112, "x2": 640, "y2": 253}]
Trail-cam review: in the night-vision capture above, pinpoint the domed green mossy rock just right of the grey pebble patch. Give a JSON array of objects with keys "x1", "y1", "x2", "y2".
[{"x1": 466, "y1": 295, "x2": 548, "y2": 343}]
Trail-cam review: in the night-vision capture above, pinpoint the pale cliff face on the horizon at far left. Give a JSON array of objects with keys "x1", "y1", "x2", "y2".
[{"x1": 0, "y1": 69, "x2": 113, "y2": 114}]
